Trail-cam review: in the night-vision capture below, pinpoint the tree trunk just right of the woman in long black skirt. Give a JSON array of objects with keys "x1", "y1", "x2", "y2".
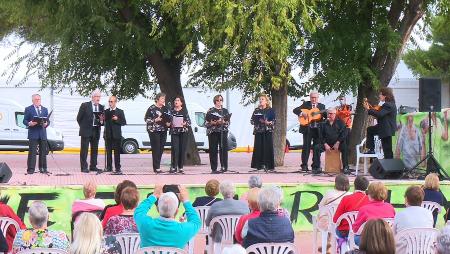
[{"x1": 271, "y1": 85, "x2": 287, "y2": 167}]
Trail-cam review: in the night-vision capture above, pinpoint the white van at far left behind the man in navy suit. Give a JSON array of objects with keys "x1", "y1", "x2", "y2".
[{"x1": 0, "y1": 99, "x2": 64, "y2": 151}]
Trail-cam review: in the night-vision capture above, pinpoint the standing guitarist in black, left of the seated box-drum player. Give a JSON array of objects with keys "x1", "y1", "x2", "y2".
[{"x1": 293, "y1": 91, "x2": 326, "y2": 173}]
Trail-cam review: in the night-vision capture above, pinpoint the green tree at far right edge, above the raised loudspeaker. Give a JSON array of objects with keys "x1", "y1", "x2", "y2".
[{"x1": 403, "y1": 15, "x2": 450, "y2": 82}]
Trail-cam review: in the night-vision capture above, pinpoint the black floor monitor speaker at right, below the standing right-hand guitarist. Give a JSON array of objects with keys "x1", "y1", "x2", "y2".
[{"x1": 369, "y1": 159, "x2": 405, "y2": 179}]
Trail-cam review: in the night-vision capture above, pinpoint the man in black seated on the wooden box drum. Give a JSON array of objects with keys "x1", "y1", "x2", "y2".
[{"x1": 313, "y1": 108, "x2": 350, "y2": 174}]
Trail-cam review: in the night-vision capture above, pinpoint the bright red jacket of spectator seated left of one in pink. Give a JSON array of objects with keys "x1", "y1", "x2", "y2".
[{"x1": 333, "y1": 191, "x2": 369, "y2": 231}]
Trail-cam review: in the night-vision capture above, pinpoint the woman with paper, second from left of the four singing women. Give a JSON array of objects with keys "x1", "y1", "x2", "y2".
[{"x1": 169, "y1": 96, "x2": 191, "y2": 173}]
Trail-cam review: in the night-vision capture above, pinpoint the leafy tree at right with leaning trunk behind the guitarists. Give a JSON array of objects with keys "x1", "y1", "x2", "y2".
[{"x1": 298, "y1": 0, "x2": 448, "y2": 163}]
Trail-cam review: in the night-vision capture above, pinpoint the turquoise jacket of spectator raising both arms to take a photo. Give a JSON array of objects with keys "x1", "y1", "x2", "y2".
[{"x1": 134, "y1": 195, "x2": 202, "y2": 249}]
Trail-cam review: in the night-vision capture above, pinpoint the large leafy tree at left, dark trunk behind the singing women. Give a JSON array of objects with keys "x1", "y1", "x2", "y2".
[{"x1": 0, "y1": 0, "x2": 205, "y2": 164}]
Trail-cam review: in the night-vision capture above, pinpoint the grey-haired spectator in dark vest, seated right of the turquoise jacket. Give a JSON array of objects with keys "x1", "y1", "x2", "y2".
[{"x1": 242, "y1": 187, "x2": 294, "y2": 248}]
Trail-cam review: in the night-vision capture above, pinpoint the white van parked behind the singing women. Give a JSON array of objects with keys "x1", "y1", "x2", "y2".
[{"x1": 122, "y1": 103, "x2": 237, "y2": 154}]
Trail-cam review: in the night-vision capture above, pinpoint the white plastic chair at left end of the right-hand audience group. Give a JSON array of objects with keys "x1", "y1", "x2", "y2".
[{"x1": 312, "y1": 204, "x2": 337, "y2": 254}]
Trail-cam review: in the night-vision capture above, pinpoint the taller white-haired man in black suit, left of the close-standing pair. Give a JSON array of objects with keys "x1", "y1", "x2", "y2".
[{"x1": 77, "y1": 90, "x2": 105, "y2": 173}]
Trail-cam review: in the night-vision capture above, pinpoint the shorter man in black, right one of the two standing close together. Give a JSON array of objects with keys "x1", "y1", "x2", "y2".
[{"x1": 103, "y1": 96, "x2": 127, "y2": 174}]
